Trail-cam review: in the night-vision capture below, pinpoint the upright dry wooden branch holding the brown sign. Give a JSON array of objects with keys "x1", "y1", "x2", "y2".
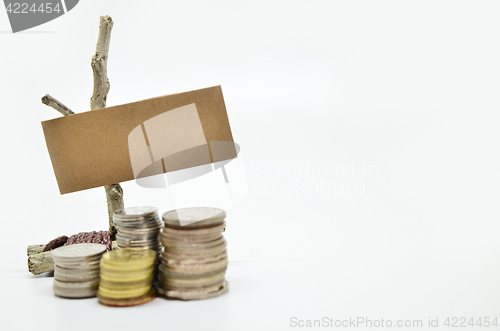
[{"x1": 90, "y1": 16, "x2": 123, "y2": 240}]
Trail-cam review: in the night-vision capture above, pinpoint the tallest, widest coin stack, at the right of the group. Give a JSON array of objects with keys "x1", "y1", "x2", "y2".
[{"x1": 157, "y1": 208, "x2": 229, "y2": 300}]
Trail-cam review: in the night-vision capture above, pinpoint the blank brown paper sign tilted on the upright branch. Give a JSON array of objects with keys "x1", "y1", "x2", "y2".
[{"x1": 42, "y1": 86, "x2": 237, "y2": 194}]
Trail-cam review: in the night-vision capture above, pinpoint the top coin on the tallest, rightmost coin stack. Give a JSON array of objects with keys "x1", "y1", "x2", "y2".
[{"x1": 162, "y1": 207, "x2": 226, "y2": 228}]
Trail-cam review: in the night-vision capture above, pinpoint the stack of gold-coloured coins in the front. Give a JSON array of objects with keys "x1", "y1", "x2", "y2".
[{"x1": 97, "y1": 248, "x2": 157, "y2": 307}]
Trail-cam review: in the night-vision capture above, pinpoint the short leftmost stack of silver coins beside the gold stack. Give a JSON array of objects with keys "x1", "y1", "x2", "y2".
[{"x1": 51, "y1": 244, "x2": 106, "y2": 298}]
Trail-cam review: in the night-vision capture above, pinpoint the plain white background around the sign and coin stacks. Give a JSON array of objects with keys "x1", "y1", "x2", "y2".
[{"x1": 0, "y1": 0, "x2": 500, "y2": 330}]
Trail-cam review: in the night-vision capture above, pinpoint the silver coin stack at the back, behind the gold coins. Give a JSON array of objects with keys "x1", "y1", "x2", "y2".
[{"x1": 113, "y1": 207, "x2": 163, "y2": 252}]
